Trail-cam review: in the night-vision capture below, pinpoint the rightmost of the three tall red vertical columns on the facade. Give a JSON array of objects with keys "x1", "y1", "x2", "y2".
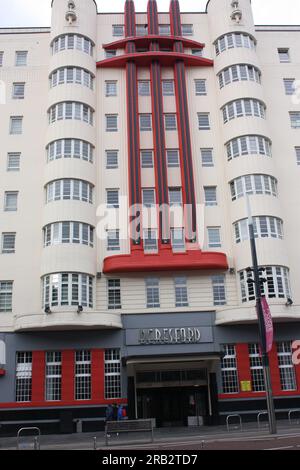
[{"x1": 170, "y1": 0, "x2": 197, "y2": 242}]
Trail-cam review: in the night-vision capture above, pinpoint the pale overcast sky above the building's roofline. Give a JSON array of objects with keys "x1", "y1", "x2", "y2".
[{"x1": 0, "y1": 0, "x2": 300, "y2": 27}]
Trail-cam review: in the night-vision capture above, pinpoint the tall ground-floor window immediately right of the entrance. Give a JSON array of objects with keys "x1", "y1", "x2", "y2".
[{"x1": 221, "y1": 344, "x2": 239, "y2": 393}]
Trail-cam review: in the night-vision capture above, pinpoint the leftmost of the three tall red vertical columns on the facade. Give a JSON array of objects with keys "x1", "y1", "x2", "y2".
[{"x1": 125, "y1": 0, "x2": 142, "y2": 247}]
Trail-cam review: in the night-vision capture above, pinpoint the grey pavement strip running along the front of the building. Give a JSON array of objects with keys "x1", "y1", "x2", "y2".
[{"x1": 0, "y1": 421, "x2": 300, "y2": 451}]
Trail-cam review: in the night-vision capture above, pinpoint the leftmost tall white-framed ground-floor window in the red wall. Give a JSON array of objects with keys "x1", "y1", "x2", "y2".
[{"x1": 16, "y1": 352, "x2": 32, "y2": 402}]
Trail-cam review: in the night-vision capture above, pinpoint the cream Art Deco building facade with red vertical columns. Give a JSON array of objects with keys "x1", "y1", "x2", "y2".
[{"x1": 0, "y1": 0, "x2": 300, "y2": 434}]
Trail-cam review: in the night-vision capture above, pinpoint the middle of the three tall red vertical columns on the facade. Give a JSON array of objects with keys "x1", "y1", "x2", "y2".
[{"x1": 147, "y1": 0, "x2": 170, "y2": 242}]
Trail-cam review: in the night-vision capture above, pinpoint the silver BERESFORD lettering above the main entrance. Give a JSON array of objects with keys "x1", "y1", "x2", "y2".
[{"x1": 139, "y1": 327, "x2": 201, "y2": 344}]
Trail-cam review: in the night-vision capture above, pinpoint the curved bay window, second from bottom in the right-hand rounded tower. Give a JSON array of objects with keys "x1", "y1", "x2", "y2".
[{"x1": 234, "y1": 216, "x2": 283, "y2": 243}]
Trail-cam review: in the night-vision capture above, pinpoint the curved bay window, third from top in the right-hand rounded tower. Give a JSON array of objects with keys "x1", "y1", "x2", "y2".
[{"x1": 222, "y1": 99, "x2": 266, "y2": 124}]
